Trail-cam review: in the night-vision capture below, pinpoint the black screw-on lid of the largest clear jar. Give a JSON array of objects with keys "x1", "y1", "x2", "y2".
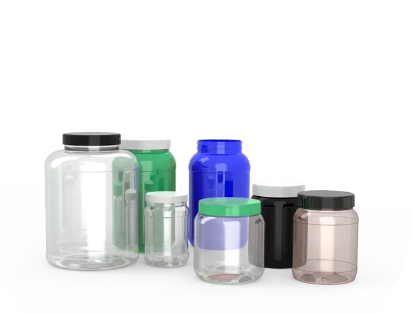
[{"x1": 63, "y1": 132, "x2": 121, "y2": 146}]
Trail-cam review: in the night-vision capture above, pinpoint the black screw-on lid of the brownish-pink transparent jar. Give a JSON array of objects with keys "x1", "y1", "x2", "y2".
[{"x1": 298, "y1": 191, "x2": 355, "y2": 210}]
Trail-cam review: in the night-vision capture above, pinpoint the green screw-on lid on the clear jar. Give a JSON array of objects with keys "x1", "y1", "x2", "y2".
[{"x1": 199, "y1": 197, "x2": 261, "y2": 217}]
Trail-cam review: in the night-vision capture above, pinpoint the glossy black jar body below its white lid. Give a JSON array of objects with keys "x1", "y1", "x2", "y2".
[{"x1": 252, "y1": 195, "x2": 298, "y2": 268}]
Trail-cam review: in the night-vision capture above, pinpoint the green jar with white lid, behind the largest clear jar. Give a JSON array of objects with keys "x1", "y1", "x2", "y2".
[{"x1": 121, "y1": 137, "x2": 176, "y2": 253}]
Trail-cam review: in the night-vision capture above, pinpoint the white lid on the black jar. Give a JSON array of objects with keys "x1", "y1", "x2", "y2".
[{"x1": 253, "y1": 181, "x2": 305, "y2": 197}]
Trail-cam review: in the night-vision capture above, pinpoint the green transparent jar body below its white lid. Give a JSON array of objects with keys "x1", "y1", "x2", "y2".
[{"x1": 129, "y1": 149, "x2": 176, "y2": 253}]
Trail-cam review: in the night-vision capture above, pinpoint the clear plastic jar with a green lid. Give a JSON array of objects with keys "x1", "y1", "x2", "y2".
[{"x1": 194, "y1": 197, "x2": 265, "y2": 285}]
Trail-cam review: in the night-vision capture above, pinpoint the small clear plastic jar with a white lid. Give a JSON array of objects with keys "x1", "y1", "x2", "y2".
[{"x1": 144, "y1": 192, "x2": 189, "y2": 267}]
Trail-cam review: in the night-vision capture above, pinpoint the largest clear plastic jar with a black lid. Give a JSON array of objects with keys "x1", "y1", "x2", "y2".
[{"x1": 45, "y1": 133, "x2": 139, "y2": 270}]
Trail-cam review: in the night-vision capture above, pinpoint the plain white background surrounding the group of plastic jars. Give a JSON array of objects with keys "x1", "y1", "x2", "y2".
[{"x1": 0, "y1": 0, "x2": 412, "y2": 314}]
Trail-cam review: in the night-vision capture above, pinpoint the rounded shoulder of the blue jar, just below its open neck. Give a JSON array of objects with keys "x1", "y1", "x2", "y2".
[{"x1": 189, "y1": 153, "x2": 250, "y2": 172}]
